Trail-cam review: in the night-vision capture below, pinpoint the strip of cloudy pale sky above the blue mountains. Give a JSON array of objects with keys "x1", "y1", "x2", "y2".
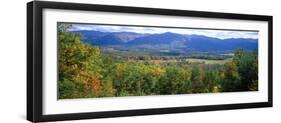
[{"x1": 69, "y1": 24, "x2": 258, "y2": 39}]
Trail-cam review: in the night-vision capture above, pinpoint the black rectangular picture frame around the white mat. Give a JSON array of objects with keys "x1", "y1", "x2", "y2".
[{"x1": 27, "y1": 1, "x2": 273, "y2": 122}]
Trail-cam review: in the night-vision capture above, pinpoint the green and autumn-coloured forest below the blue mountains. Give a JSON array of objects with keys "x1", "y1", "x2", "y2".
[{"x1": 58, "y1": 24, "x2": 258, "y2": 99}]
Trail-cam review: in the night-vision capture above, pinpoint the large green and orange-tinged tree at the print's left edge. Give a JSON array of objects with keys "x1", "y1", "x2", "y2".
[{"x1": 58, "y1": 24, "x2": 102, "y2": 98}]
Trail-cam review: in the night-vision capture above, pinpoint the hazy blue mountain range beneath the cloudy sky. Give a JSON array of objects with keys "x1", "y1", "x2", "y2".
[{"x1": 72, "y1": 30, "x2": 258, "y2": 53}]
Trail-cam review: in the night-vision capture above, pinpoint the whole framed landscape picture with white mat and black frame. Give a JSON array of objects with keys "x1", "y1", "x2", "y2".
[{"x1": 27, "y1": 1, "x2": 272, "y2": 122}]
